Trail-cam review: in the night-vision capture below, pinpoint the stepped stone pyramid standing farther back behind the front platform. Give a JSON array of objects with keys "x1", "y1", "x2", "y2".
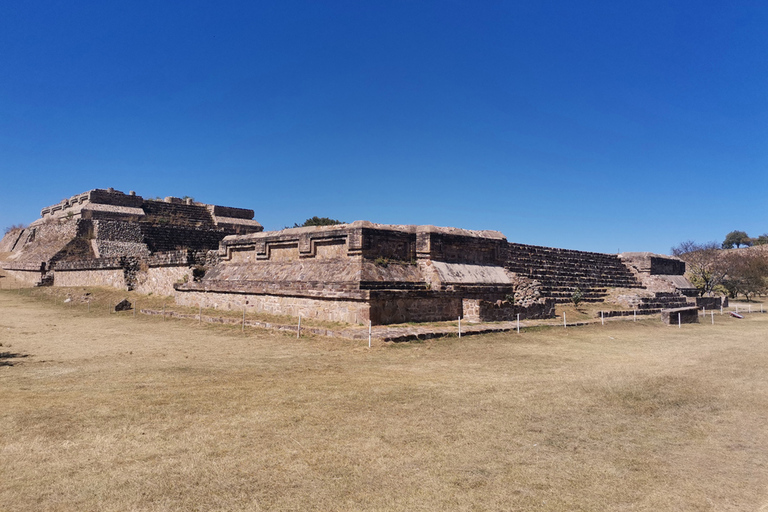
[{"x1": 0, "y1": 189, "x2": 263, "y2": 292}]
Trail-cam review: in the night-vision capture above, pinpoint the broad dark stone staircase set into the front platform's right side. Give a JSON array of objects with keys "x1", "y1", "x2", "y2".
[{"x1": 505, "y1": 243, "x2": 643, "y2": 303}]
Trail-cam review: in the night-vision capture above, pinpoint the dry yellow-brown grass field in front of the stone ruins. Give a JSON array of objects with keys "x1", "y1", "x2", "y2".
[{"x1": 0, "y1": 290, "x2": 768, "y2": 511}]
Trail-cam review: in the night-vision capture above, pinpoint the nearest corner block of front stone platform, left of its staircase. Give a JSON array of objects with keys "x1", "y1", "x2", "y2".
[{"x1": 176, "y1": 221, "x2": 554, "y2": 324}]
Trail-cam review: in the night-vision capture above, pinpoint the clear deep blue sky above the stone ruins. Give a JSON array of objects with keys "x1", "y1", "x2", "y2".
[{"x1": 0, "y1": 0, "x2": 768, "y2": 253}]
